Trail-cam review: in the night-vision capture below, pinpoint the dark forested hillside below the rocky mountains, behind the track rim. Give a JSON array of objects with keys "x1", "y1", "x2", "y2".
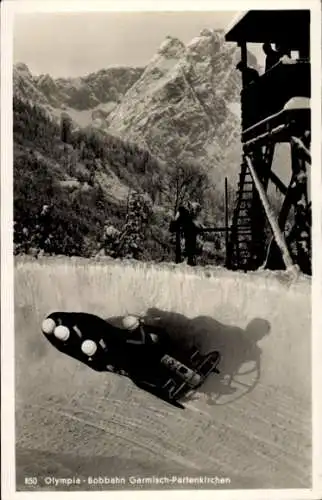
[{"x1": 14, "y1": 97, "x2": 228, "y2": 261}]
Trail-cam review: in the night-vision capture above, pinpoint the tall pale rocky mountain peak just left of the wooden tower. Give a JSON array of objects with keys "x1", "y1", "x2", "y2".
[{"x1": 109, "y1": 29, "x2": 245, "y2": 178}]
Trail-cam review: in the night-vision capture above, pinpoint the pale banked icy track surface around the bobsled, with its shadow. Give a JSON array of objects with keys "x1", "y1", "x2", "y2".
[{"x1": 15, "y1": 258, "x2": 311, "y2": 491}]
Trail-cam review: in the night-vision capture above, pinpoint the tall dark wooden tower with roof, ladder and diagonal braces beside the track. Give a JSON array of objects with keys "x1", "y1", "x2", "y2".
[{"x1": 225, "y1": 10, "x2": 311, "y2": 274}]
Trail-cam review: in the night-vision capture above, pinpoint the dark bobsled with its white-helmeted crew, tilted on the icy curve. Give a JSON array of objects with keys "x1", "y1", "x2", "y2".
[{"x1": 42, "y1": 312, "x2": 220, "y2": 409}]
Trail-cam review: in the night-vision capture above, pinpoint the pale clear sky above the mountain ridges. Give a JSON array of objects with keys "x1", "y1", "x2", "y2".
[{"x1": 14, "y1": 11, "x2": 243, "y2": 78}]
